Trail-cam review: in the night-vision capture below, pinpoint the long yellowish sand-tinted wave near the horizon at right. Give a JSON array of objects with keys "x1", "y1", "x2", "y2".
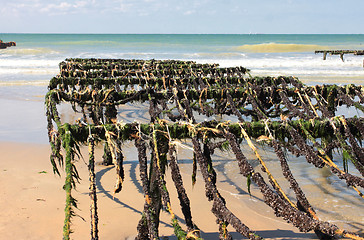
[{"x1": 234, "y1": 43, "x2": 333, "y2": 53}]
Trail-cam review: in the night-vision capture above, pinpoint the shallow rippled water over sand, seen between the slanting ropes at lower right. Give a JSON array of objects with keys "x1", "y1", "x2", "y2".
[{"x1": 174, "y1": 142, "x2": 364, "y2": 234}]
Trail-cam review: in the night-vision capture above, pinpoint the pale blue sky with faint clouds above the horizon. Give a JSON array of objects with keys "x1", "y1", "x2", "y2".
[{"x1": 0, "y1": 0, "x2": 364, "y2": 34}]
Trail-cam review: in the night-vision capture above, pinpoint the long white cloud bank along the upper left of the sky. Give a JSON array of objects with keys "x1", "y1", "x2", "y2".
[{"x1": 0, "y1": 0, "x2": 185, "y2": 17}]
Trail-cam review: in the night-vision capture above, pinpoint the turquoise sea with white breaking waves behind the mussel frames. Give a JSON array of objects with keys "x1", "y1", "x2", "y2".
[{"x1": 0, "y1": 34, "x2": 364, "y2": 90}]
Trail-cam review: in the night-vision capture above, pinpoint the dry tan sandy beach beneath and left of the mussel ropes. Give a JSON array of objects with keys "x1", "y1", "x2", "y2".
[{"x1": 0, "y1": 138, "x2": 320, "y2": 239}]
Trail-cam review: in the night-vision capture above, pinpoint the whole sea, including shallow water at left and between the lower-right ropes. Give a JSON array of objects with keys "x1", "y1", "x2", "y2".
[{"x1": 0, "y1": 33, "x2": 364, "y2": 236}]
